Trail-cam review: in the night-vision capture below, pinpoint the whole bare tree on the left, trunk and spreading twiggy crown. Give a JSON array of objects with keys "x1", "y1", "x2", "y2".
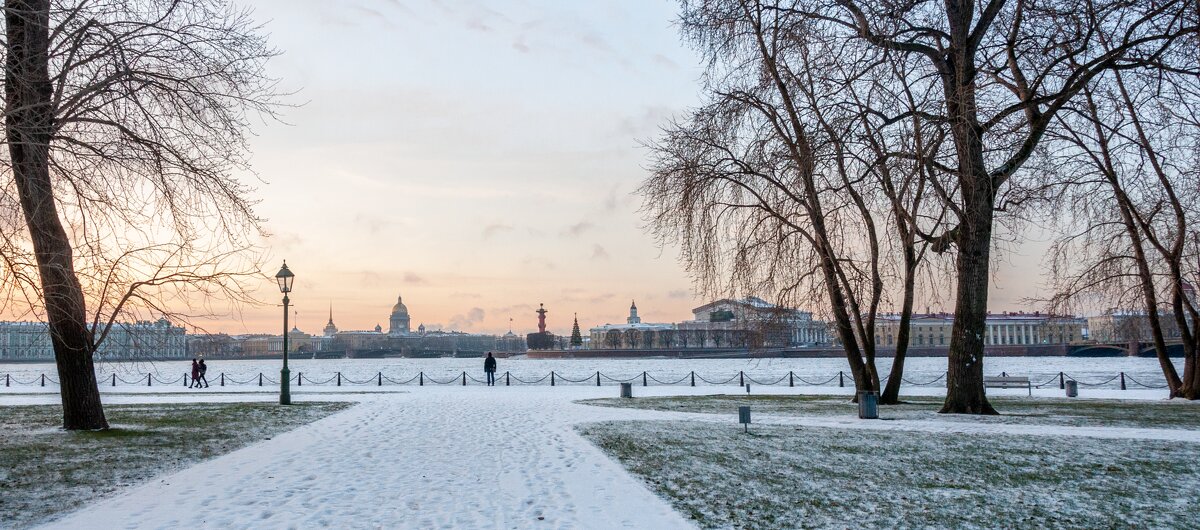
[{"x1": 0, "y1": 0, "x2": 281, "y2": 429}]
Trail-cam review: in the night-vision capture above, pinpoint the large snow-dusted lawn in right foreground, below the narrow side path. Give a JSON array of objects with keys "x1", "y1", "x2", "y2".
[{"x1": 580, "y1": 421, "x2": 1200, "y2": 529}]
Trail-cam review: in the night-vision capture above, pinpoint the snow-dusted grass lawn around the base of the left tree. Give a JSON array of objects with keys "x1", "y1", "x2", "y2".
[{"x1": 0, "y1": 403, "x2": 352, "y2": 528}]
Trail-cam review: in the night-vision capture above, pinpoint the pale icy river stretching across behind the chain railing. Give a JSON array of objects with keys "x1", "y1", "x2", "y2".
[{"x1": 0, "y1": 357, "x2": 1182, "y2": 392}]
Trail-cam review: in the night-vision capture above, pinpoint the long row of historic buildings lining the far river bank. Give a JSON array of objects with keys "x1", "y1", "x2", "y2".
[{"x1": 0, "y1": 293, "x2": 1180, "y2": 362}]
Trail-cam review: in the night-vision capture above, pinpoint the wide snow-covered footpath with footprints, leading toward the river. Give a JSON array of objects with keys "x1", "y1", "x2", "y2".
[{"x1": 35, "y1": 387, "x2": 692, "y2": 529}]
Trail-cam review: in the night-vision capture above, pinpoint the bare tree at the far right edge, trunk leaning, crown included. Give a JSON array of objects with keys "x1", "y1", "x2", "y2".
[{"x1": 1051, "y1": 63, "x2": 1200, "y2": 399}]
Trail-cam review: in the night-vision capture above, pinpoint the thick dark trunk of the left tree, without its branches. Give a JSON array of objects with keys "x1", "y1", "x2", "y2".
[{"x1": 5, "y1": 0, "x2": 108, "y2": 429}]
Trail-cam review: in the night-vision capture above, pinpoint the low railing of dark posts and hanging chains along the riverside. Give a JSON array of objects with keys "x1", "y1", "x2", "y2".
[{"x1": 0, "y1": 371, "x2": 1166, "y2": 390}]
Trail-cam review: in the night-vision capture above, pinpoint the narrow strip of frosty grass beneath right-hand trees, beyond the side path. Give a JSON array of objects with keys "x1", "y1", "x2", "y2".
[{"x1": 581, "y1": 395, "x2": 1200, "y2": 429}]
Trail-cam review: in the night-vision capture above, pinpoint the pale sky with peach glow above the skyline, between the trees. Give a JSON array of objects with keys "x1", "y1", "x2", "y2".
[{"x1": 187, "y1": 0, "x2": 1036, "y2": 333}]
